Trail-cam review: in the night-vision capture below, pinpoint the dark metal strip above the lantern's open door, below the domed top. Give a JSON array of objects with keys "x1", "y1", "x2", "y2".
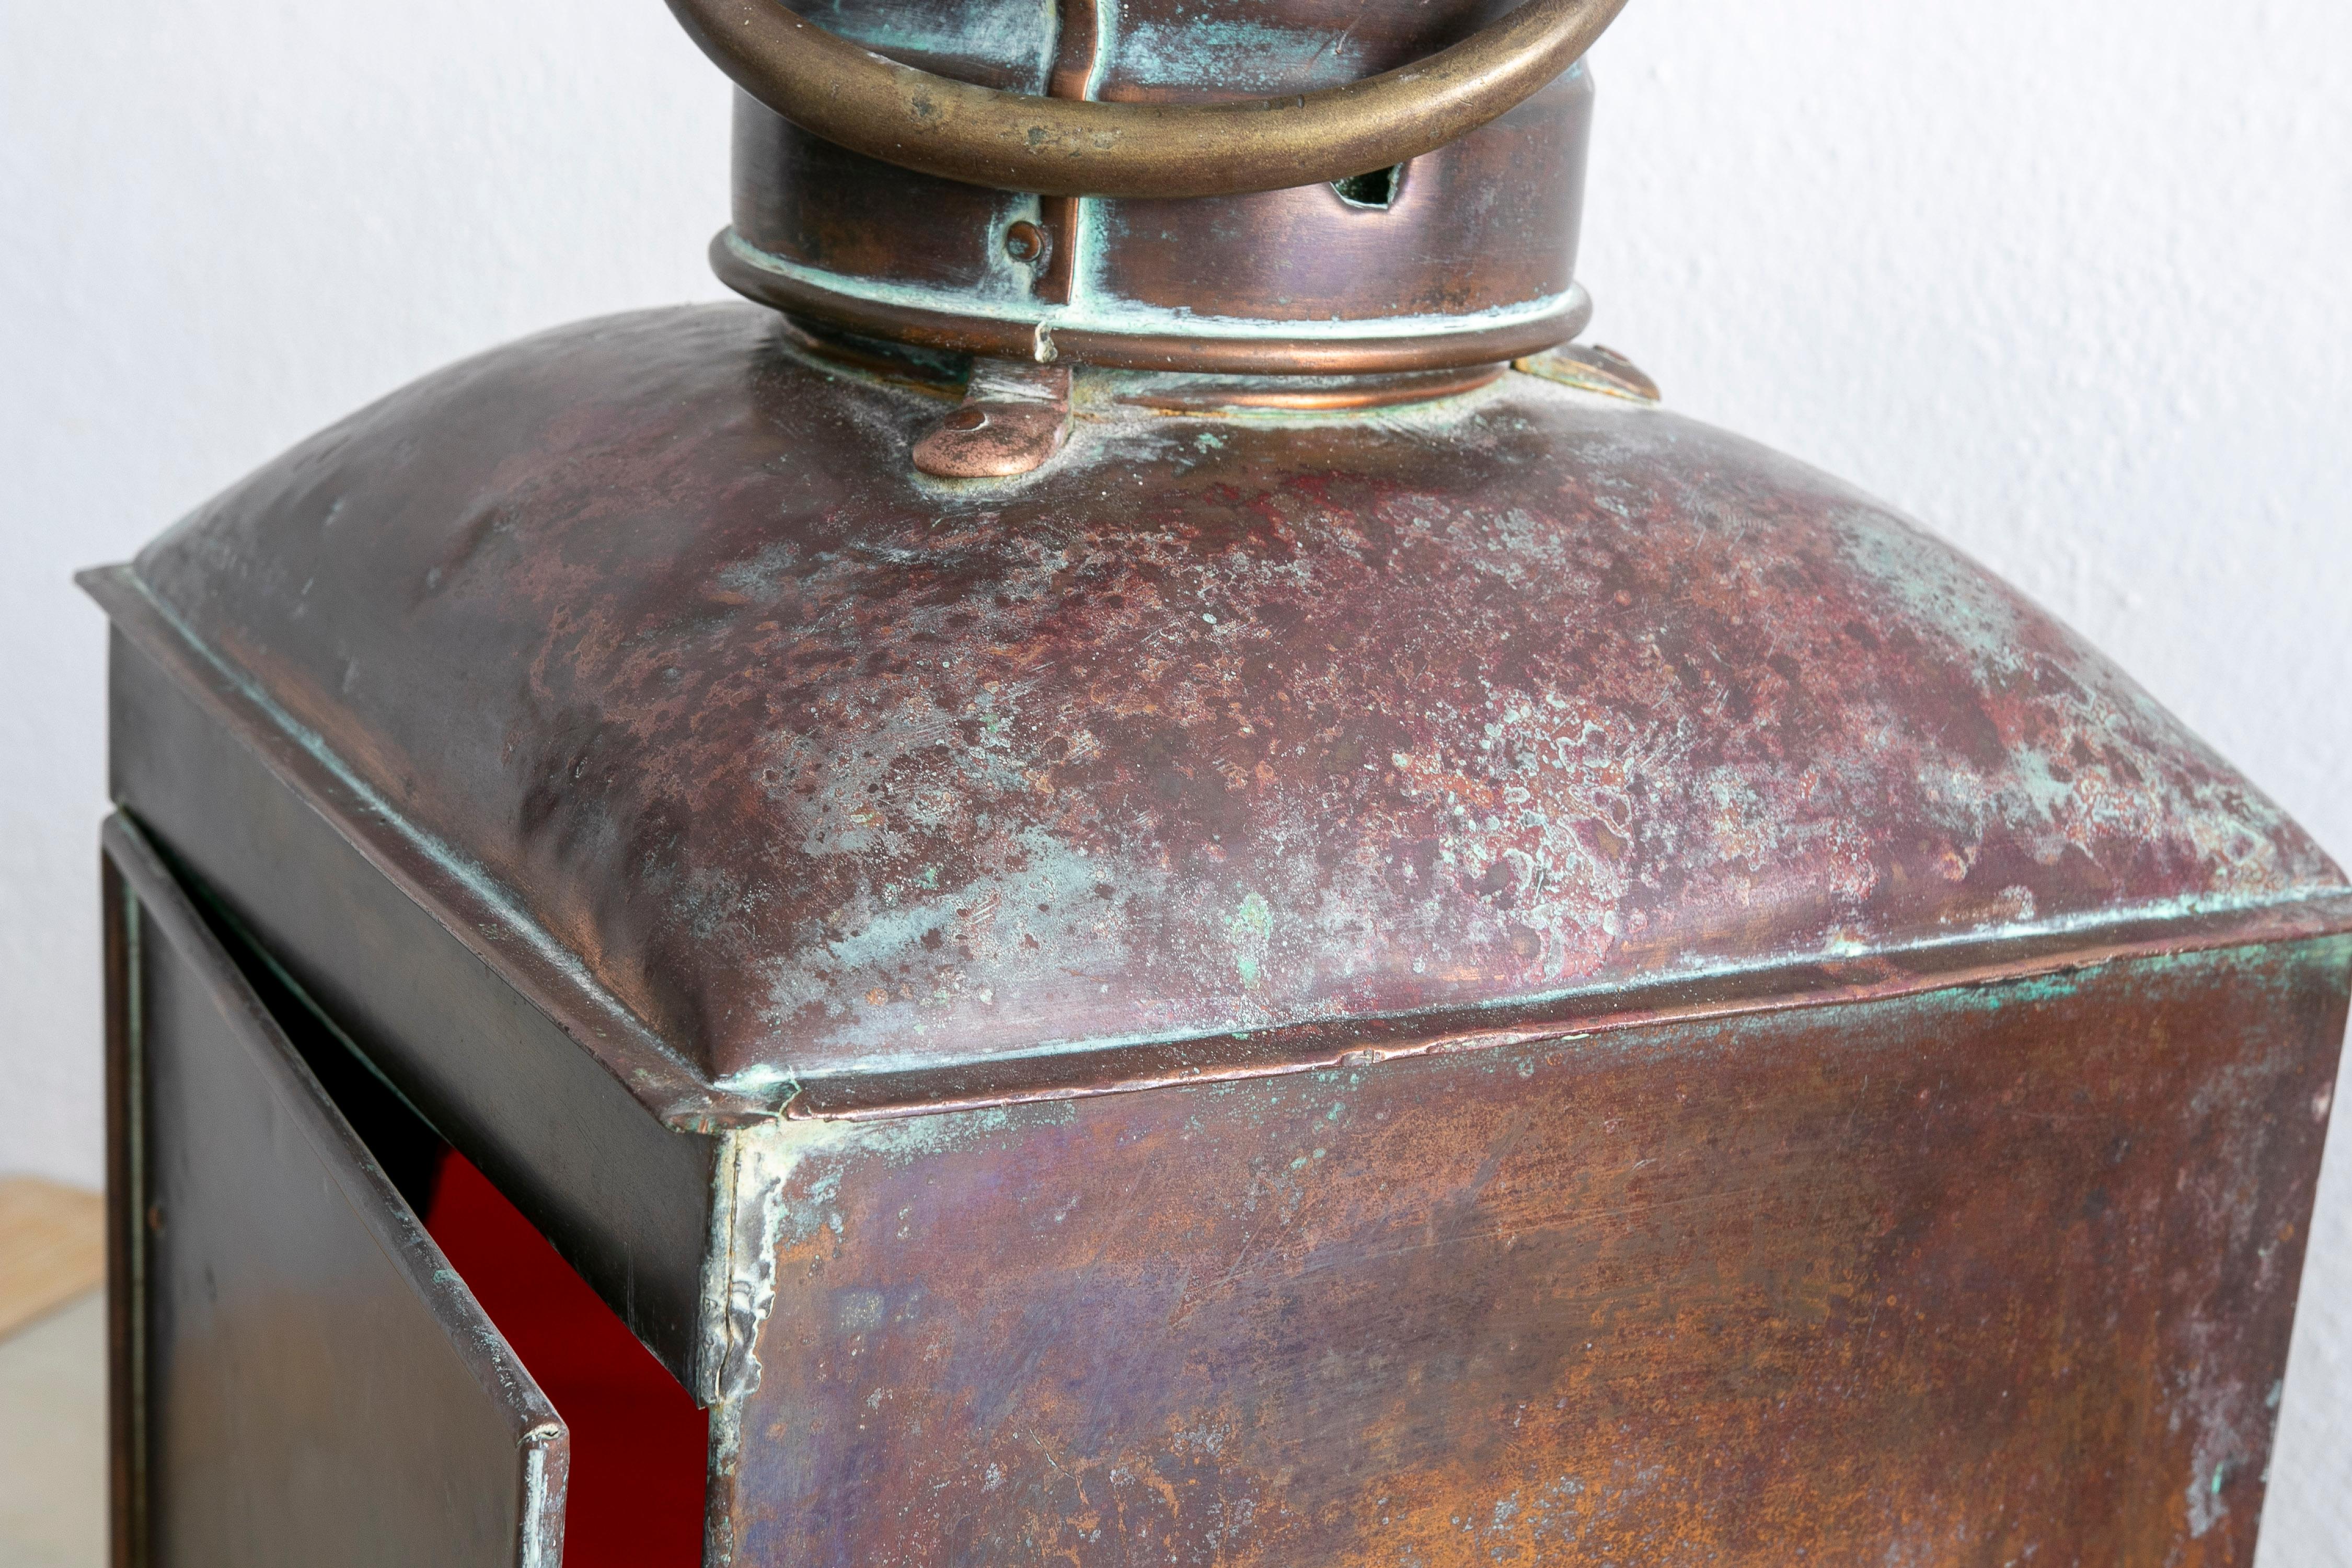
[{"x1": 85, "y1": 597, "x2": 743, "y2": 1397}]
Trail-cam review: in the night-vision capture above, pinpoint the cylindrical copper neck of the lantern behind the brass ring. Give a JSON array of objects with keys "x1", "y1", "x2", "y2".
[{"x1": 710, "y1": 0, "x2": 1593, "y2": 372}]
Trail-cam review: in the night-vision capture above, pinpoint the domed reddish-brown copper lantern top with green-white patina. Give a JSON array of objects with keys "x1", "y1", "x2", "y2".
[{"x1": 136, "y1": 306, "x2": 2343, "y2": 1086}]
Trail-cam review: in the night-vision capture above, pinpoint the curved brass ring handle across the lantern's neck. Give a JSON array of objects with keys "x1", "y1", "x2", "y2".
[{"x1": 671, "y1": 0, "x2": 1625, "y2": 195}]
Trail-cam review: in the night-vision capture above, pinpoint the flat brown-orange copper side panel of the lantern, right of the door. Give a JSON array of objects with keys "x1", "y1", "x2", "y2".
[{"x1": 715, "y1": 938, "x2": 2352, "y2": 1568}]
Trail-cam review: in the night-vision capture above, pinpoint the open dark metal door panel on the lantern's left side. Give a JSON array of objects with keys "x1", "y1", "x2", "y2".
[{"x1": 106, "y1": 818, "x2": 569, "y2": 1568}]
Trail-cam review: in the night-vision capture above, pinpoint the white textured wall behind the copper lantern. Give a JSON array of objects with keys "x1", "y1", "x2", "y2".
[{"x1": 0, "y1": 0, "x2": 2352, "y2": 1568}]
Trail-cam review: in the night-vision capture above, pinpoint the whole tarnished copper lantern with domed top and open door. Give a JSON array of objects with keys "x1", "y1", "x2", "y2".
[{"x1": 87, "y1": 0, "x2": 2352, "y2": 1568}]
